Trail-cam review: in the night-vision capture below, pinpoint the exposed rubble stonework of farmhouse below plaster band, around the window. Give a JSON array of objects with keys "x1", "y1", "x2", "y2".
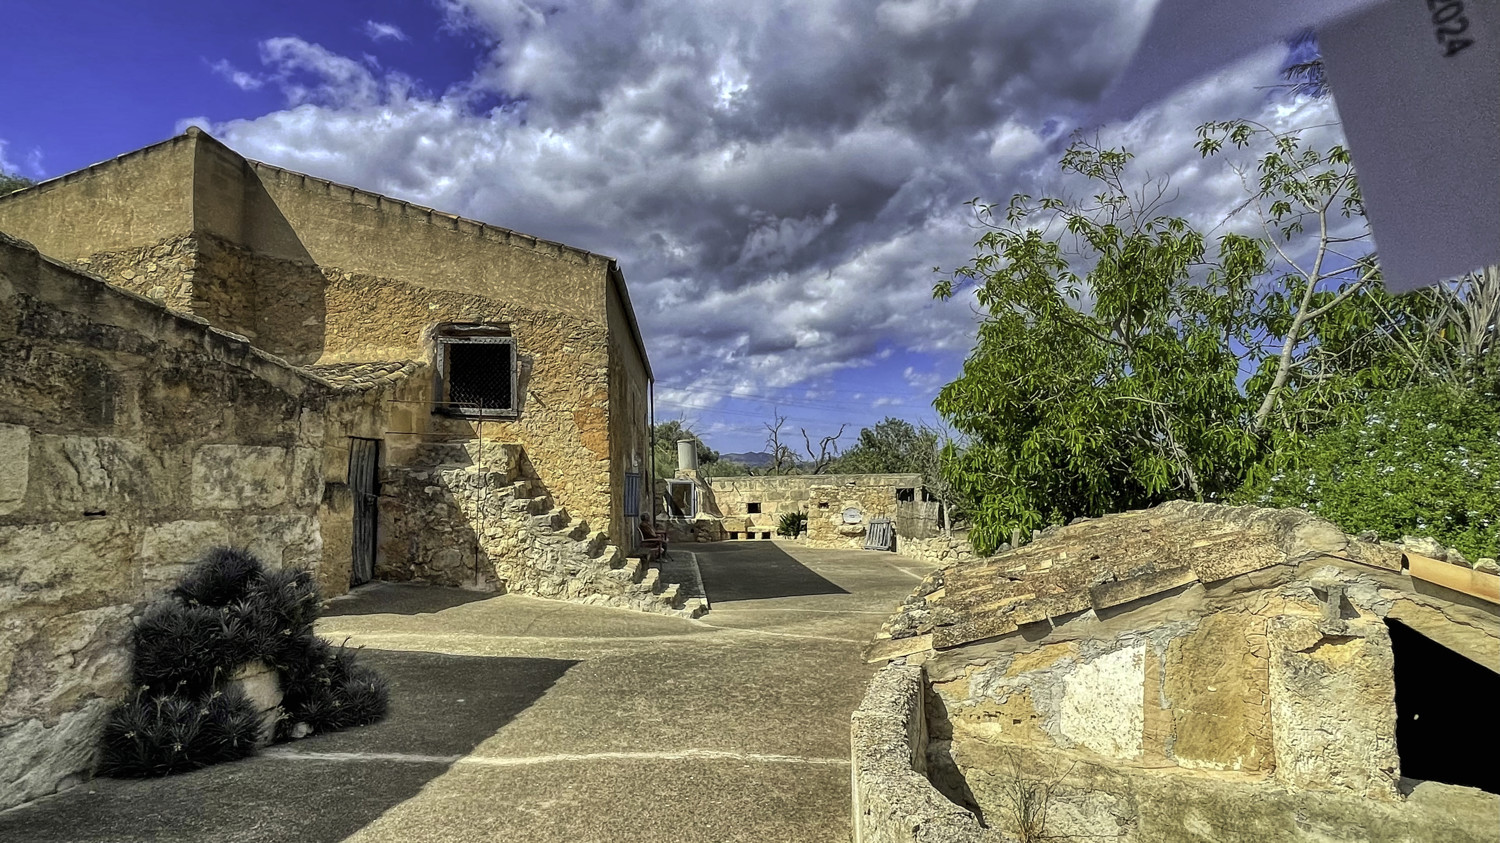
[{"x1": 66, "y1": 234, "x2": 629, "y2": 555}]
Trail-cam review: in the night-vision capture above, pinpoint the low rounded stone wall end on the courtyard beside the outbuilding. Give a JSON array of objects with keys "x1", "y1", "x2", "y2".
[{"x1": 851, "y1": 663, "x2": 1013, "y2": 843}]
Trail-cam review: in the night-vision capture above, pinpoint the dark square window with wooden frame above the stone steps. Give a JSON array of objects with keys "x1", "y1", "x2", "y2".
[{"x1": 438, "y1": 327, "x2": 519, "y2": 419}]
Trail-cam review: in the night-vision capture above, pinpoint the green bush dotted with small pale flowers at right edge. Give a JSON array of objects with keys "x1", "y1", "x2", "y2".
[{"x1": 1235, "y1": 386, "x2": 1500, "y2": 558}]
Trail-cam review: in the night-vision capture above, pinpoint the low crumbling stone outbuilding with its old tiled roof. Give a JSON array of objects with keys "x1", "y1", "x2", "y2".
[{"x1": 870, "y1": 504, "x2": 1500, "y2": 842}]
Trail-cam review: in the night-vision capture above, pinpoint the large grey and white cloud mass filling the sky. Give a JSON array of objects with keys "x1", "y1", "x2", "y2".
[{"x1": 187, "y1": 0, "x2": 1337, "y2": 447}]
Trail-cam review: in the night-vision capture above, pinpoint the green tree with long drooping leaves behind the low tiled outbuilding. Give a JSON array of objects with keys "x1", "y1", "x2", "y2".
[{"x1": 935, "y1": 141, "x2": 1268, "y2": 552}]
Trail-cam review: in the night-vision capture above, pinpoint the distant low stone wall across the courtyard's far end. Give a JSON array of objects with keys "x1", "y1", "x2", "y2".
[{"x1": 708, "y1": 474, "x2": 923, "y2": 548}]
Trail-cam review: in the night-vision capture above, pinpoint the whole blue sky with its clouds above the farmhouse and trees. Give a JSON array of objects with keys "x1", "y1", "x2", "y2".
[{"x1": 0, "y1": 0, "x2": 1337, "y2": 452}]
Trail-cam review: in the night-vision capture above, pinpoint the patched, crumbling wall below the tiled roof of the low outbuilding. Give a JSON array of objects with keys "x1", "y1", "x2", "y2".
[{"x1": 915, "y1": 563, "x2": 1500, "y2": 843}]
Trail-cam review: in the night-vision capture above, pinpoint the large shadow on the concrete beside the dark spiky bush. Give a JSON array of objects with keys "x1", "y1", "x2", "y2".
[{"x1": 0, "y1": 650, "x2": 578, "y2": 843}]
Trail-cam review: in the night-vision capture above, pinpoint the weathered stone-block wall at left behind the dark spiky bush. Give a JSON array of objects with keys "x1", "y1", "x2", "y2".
[{"x1": 0, "y1": 229, "x2": 327, "y2": 807}]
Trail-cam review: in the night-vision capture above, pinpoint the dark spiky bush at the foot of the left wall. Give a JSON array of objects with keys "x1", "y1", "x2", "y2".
[{"x1": 104, "y1": 548, "x2": 389, "y2": 776}]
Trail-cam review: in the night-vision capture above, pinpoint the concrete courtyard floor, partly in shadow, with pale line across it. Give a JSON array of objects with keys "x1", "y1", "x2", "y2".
[{"x1": 0, "y1": 542, "x2": 924, "y2": 843}]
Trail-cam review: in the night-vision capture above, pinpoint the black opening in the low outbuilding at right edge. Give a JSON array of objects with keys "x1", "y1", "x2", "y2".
[{"x1": 1386, "y1": 621, "x2": 1500, "y2": 794}]
